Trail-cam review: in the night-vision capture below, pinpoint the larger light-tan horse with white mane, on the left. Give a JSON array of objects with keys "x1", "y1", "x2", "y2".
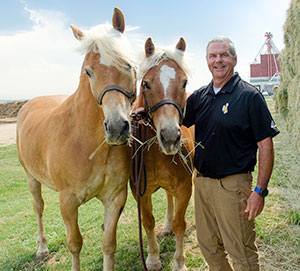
[{"x1": 17, "y1": 8, "x2": 136, "y2": 271}]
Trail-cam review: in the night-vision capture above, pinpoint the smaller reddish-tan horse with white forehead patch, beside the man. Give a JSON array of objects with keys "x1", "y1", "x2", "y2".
[{"x1": 131, "y1": 38, "x2": 194, "y2": 270}]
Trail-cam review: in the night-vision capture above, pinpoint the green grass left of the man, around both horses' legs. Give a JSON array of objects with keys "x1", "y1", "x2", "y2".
[{"x1": 0, "y1": 145, "x2": 204, "y2": 271}]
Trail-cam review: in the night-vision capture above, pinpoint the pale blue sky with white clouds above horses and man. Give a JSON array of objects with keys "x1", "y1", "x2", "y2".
[{"x1": 0, "y1": 0, "x2": 290, "y2": 100}]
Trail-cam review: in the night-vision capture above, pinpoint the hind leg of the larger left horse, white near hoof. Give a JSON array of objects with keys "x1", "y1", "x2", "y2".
[{"x1": 28, "y1": 175, "x2": 49, "y2": 259}]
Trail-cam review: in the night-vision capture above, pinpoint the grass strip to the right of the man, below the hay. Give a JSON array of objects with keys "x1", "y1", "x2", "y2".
[{"x1": 256, "y1": 98, "x2": 300, "y2": 271}]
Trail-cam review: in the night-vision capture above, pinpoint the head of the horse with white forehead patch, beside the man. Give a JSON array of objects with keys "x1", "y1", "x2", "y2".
[{"x1": 141, "y1": 38, "x2": 187, "y2": 155}]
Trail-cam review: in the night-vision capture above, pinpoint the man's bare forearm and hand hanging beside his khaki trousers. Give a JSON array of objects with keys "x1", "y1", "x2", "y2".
[{"x1": 245, "y1": 137, "x2": 274, "y2": 220}]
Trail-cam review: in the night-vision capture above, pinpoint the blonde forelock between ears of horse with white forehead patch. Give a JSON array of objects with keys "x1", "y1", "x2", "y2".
[{"x1": 137, "y1": 47, "x2": 191, "y2": 80}]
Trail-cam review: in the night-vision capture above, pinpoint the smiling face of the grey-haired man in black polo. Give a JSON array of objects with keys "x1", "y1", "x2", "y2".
[{"x1": 207, "y1": 41, "x2": 237, "y2": 81}]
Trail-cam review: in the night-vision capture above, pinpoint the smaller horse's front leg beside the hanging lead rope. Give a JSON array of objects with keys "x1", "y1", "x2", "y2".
[{"x1": 141, "y1": 195, "x2": 161, "y2": 271}]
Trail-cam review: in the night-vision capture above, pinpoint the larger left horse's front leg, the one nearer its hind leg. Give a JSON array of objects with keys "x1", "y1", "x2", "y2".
[{"x1": 59, "y1": 191, "x2": 82, "y2": 271}]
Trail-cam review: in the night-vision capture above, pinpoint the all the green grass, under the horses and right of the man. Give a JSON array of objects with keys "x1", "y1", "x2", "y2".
[{"x1": 0, "y1": 96, "x2": 300, "y2": 271}]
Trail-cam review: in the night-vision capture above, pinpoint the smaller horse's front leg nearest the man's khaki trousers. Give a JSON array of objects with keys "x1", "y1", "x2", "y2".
[{"x1": 172, "y1": 182, "x2": 192, "y2": 271}]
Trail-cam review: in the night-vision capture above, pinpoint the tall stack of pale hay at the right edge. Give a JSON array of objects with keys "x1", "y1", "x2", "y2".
[{"x1": 275, "y1": 0, "x2": 300, "y2": 149}]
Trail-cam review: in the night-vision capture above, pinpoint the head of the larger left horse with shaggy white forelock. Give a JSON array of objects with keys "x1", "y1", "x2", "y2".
[{"x1": 71, "y1": 8, "x2": 136, "y2": 145}]
